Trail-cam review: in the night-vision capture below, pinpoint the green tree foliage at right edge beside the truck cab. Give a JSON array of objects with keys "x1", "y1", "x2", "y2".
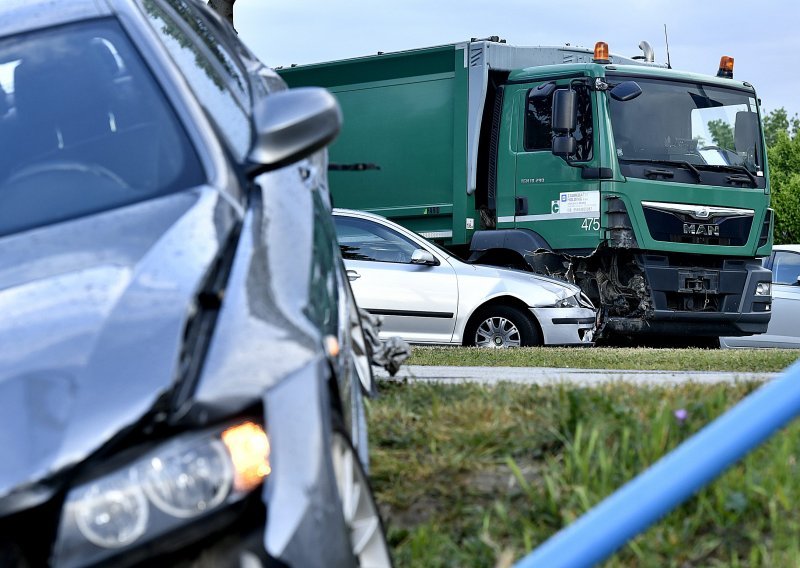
[{"x1": 764, "y1": 108, "x2": 800, "y2": 244}]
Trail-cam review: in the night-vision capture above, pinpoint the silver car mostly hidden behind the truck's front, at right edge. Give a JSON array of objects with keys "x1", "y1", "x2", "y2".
[{"x1": 719, "y1": 245, "x2": 800, "y2": 348}]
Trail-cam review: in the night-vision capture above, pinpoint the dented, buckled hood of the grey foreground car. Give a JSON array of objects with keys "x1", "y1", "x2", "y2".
[{"x1": 0, "y1": 187, "x2": 240, "y2": 504}]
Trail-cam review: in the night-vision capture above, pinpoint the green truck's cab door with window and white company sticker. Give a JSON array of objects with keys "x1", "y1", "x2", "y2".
[{"x1": 510, "y1": 78, "x2": 600, "y2": 251}]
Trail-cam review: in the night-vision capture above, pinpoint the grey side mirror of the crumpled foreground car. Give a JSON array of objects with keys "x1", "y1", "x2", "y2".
[{"x1": 248, "y1": 87, "x2": 342, "y2": 176}]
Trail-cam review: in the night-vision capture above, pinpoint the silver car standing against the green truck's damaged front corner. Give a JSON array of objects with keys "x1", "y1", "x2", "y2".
[{"x1": 334, "y1": 209, "x2": 595, "y2": 347}]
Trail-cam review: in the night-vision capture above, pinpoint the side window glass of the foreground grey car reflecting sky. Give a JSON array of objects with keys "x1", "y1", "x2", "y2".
[{"x1": 144, "y1": 0, "x2": 252, "y2": 160}]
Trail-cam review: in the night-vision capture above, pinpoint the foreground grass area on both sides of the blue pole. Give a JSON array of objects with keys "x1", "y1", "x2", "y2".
[{"x1": 369, "y1": 383, "x2": 800, "y2": 568}]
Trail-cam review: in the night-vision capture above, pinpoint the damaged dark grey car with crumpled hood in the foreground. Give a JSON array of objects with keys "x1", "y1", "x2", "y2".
[{"x1": 0, "y1": 0, "x2": 390, "y2": 566}]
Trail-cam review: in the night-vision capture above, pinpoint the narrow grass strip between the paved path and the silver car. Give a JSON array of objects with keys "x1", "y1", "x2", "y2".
[{"x1": 408, "y1": 346, "x2": 800, "y2": 373}]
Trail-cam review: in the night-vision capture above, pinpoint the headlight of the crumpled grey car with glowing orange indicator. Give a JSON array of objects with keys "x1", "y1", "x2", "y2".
[{"x1": 54, "y1": 422, "x2": 270, "y2": 566}]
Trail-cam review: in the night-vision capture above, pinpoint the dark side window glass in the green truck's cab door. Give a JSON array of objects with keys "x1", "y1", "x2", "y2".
[{"x1": 524, "y1": 85, "x2": 594, "y2": 162}]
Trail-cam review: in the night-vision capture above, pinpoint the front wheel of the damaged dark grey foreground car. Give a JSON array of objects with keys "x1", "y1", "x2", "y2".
[{"x1": 332, "y1": 431, "x2": 392, "y2": 568}]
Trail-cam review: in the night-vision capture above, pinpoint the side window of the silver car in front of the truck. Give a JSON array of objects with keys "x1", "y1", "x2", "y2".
[{"x1": 334, "y1": 216, "x2": 419, "y2": 264}]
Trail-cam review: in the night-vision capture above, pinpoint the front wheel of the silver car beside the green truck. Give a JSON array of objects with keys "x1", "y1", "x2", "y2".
[{"x1": 464, "y1": 306, "x2": 542, "y2": 349}]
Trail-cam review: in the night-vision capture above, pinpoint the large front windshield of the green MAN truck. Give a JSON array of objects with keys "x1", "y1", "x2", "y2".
[{"x1": 608, "y1": 77, "x2": 764, "y2": 179}]
